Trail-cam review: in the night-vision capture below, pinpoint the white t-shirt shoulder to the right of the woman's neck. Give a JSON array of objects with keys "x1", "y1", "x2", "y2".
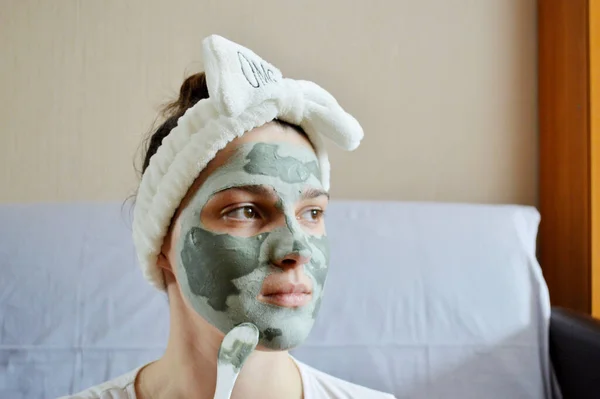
[{"x1": 294, "y1": 359, "x2": 395, "y2": 399}]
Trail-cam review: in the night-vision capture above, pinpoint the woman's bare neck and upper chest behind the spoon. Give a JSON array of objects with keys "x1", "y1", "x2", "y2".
[{"x1": 136, "y1": 285, "x2": 303, "y2": 399}]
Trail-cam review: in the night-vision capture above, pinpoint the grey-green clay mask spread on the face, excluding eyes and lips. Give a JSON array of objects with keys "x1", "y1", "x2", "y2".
[{"x1": 176, "y1": 142, "x2": 329, "y2": 350}]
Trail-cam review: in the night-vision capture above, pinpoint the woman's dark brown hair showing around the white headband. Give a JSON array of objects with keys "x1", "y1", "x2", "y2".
[{"x1": 141, "y1": 72, "x2": 306, "y2": 174}]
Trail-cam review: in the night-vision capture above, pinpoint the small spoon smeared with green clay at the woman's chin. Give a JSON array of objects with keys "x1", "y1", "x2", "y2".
[{"x1": 214, "y1": 323, "x2": 259, "y2": 399}]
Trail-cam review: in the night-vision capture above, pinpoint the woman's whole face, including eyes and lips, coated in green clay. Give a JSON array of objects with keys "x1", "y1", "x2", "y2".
[{"x1": 165, "y1": 123, "x2": 329, "y2": 350}]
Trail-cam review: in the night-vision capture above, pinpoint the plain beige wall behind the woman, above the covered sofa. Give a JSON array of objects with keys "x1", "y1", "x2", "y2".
[{"x1": 0, "y1": 0, "x2": 537, "y2": 204}]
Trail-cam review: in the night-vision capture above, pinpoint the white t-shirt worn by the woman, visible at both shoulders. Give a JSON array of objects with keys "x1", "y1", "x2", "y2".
[{"x1": 59, "y1": 359, "x2": 395, "y2": 399}]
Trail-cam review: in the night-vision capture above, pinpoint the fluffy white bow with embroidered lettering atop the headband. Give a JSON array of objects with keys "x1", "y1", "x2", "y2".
[{"x1": 203, "y1": 35, "x2": 363, "y2": 150}]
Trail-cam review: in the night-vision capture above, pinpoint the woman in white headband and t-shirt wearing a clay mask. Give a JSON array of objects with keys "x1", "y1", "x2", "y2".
[{"x1": 63, "y1": 36, "x2": 392, "y2": 399}]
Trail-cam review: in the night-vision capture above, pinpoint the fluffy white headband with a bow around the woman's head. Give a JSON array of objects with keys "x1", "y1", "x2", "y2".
[{"x1": 133, "y1": 35, "x2": 363, "y2": 289}]
